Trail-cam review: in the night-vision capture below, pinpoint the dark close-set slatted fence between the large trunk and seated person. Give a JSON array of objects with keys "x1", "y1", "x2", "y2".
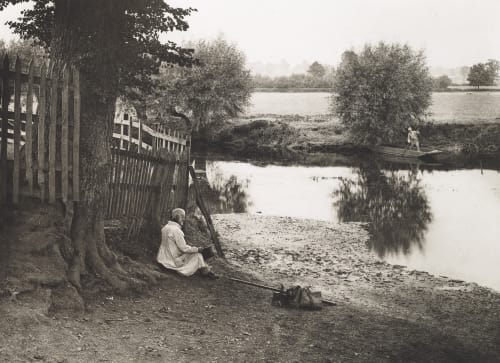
[{"x1": 106, "y1": 148, "x2": 189, "y2": 235}]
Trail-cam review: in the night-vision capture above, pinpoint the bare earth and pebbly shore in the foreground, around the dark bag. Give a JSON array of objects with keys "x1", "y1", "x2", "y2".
[{"x1": 0, "y1": 215, "x2": 500, "y2": 363}]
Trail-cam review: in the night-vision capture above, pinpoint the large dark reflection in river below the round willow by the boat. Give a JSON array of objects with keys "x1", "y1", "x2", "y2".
[{"x1": 333, "y1": 166, "x2": 432, "y2": 257}]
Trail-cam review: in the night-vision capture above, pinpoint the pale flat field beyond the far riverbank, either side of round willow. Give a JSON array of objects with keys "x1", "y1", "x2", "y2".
[{"x1": 247, "y1": 92, "x2": 500, "y2": 123}]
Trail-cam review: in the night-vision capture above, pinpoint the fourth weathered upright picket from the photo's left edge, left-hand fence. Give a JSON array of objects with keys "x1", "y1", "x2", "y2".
[{"x1": 37, "y1": 63, "x2": 47, "y2": 202}]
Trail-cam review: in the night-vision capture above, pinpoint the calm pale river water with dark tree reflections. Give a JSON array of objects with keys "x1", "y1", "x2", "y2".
[{"x1": 202, "y1": 161, "x2": 500, "y2": 291}]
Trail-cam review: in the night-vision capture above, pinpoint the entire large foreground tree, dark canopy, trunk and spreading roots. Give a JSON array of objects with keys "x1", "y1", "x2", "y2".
[{"x1": 0, "y1": 0, "x2": 193, "y2": 289}]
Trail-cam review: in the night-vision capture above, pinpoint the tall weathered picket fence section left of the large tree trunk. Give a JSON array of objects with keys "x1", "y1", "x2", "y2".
[{"x1": 0, "y1": 55, "x2": 80, "y2": 204}]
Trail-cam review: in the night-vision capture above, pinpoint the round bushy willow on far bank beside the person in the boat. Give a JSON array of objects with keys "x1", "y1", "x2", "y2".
[{"x1": 332, "y1": 43, "x2": 432, "y2": 144}]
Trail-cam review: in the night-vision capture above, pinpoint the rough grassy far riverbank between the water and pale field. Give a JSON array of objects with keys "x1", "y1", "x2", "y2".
[{"x1": 193, "y1": 115, "x2": 500, "y2": 163}]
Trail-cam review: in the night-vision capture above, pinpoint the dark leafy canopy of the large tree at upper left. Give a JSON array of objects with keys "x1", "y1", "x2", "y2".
[{"x1": 0, "y1": 0, "x2": 194, "y2": 96}]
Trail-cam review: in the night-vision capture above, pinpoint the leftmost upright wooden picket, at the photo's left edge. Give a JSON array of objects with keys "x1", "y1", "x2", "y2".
[{"x1": 0, "y1": 54, "x2": 10, "y2": 203}]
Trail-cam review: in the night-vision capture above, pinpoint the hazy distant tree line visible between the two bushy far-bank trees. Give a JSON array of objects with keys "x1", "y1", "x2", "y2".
[{"x1": 253, "y1": 62, "x2": 334, "y2": 89}]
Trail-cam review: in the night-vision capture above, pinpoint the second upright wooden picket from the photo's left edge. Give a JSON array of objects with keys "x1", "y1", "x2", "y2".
[{"x1": 12, "y1": 57, "x2": 21, "y2": 204}]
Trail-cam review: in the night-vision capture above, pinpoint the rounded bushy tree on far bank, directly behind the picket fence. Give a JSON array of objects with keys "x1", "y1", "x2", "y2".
[{"x1": 151, "y1": 38, "x2": 253, "y2": 128}]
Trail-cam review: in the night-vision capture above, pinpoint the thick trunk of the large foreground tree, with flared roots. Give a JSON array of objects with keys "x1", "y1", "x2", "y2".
[{"x1": 51, "y1": 0, "x2": 138, "y2": 290}]
